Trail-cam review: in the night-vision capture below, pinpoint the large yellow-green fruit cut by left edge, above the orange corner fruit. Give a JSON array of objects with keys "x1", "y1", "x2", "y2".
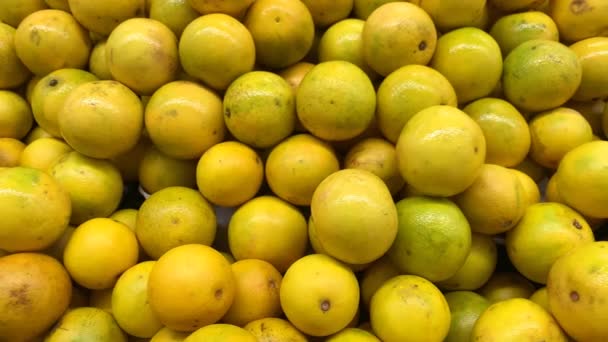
[{"x1": 0, "y1": 167, "x2": 71, "y2": 252}]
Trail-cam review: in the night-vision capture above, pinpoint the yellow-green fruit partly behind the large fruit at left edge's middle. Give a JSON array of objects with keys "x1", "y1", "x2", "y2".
[{"x1": 48, "y1": 151, "x2": 123, "y2": 225}]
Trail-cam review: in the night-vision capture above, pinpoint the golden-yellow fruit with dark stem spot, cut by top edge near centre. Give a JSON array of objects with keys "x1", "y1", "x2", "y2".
[{"x1": 244, "y1": 0, "x2": 316, "y2": 69}]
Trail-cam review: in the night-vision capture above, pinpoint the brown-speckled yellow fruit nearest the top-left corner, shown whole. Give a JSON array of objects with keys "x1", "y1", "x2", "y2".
[{"x1": 15, "y1": 9, "x2": 92, "y2": 76}]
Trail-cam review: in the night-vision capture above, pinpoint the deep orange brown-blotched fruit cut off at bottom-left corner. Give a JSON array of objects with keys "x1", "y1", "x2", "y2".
[{"x1": 0, "y1": 253, "x2": 72, "y2": 341}]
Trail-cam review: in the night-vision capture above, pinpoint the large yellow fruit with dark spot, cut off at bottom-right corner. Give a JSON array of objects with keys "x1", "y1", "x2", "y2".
[{"x1": 547, "y1": 241, "x2": 608, "y2": 341}]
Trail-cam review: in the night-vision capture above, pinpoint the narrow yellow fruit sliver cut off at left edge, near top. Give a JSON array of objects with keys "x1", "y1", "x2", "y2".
[{"x1": 0, "y1": 22, "x2": 30, "y2": 89}]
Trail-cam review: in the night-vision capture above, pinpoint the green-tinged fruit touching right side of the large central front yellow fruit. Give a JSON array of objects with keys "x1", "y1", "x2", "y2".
[{"x1": 387, "y1": 196, "x2": 471, "y2": 282}]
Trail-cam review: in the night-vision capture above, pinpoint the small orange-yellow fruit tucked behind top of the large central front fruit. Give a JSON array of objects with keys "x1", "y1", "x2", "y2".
[{"x1": 344, "y1": 138, "x2": 405, "y2": 195}]
